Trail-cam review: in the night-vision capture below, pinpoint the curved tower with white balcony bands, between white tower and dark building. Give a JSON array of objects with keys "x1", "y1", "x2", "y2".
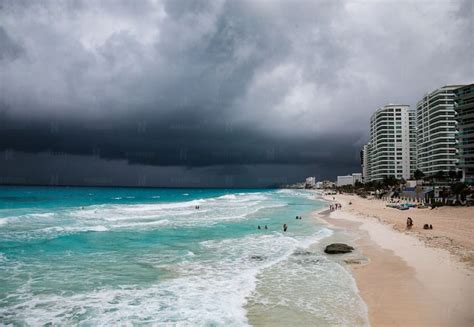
[{"x1": 416, "y1": 85, "x2": 462, "y2": 175}]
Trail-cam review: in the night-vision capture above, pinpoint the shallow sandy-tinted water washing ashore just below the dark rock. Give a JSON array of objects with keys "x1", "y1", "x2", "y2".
[{"x1": 248, "y1": 229, "x2": 369, "y2": 326}]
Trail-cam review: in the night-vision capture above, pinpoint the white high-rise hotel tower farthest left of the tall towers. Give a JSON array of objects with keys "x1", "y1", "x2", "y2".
[{"x1": 364, "y1": 104, "x2": 416, "y2": 181}]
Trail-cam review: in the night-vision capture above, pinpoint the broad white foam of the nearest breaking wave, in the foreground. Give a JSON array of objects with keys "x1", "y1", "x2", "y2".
[{"x1": 0, "y1": 230, "x2": 330, "y2": 326}]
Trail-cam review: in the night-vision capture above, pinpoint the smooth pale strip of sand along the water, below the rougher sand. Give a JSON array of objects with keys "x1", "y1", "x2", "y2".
[{"x1": 314, "y1": 195, "x2": 474, "y2": 326}]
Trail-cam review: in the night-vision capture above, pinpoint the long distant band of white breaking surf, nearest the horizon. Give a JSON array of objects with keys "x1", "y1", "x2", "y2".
[{"x1": 1, "y1": 193, "x2": 286, "y2": 240}]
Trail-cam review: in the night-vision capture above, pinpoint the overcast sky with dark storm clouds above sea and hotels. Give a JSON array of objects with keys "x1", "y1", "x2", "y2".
[{"x1": 0, "y1": 0, "x2": 474, "y2": 187}]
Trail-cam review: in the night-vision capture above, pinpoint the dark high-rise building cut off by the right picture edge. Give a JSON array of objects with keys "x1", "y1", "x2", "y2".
[{"x1": 454, "y1": 84, "x2": 474, "y2": 184}]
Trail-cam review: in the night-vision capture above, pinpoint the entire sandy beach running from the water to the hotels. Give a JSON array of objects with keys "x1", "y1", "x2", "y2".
[{"x1": 319, "y1": 195, "x2": 474, "y2": 326}]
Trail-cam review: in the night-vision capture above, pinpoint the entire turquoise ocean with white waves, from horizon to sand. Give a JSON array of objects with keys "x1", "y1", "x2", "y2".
[{"x1": 0, "y1": 187, "x2": 368, "y2": 326}]
